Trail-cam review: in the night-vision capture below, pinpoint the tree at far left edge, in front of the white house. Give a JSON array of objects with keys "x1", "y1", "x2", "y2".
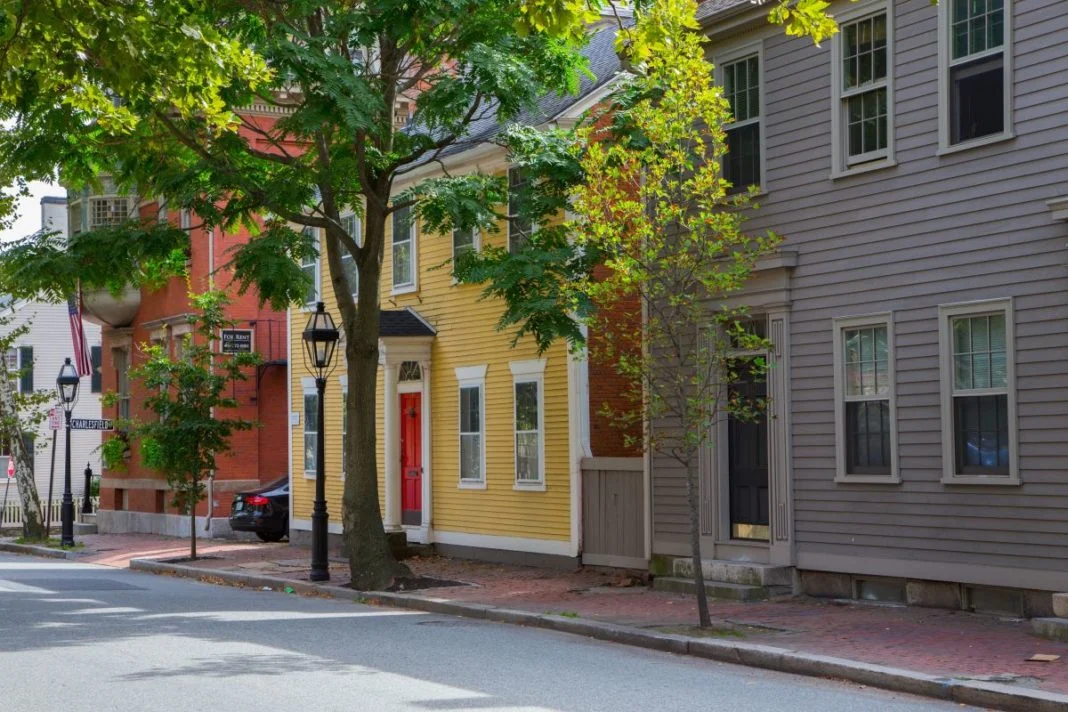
[{"x1": 0, "y1": 315, "x2": 56, "y2": 540}]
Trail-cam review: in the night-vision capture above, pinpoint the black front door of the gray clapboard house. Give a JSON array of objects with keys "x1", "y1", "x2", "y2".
[{"x1": 727, "y1": 363, "x2": 769, "y2": 541}]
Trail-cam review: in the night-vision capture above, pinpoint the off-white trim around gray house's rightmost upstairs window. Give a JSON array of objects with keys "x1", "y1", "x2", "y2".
[{"x1": 936, "y1": 0, "x2": 1016, "y2": 156}]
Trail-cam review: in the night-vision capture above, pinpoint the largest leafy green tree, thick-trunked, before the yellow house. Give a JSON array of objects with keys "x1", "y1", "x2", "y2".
[{"x1": 0, "y1": 0, "x2": 581, "y2": 589}]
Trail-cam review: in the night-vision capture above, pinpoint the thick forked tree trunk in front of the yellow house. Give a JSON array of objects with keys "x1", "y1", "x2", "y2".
[{"x1": 326, "y1": 200, "x2": 411, "y2": 590}]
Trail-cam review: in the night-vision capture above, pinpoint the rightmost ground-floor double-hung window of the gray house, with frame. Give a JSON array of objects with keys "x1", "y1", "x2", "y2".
[{"x1": 939, "y1": 299, "x2": 1019, "y2": 485}]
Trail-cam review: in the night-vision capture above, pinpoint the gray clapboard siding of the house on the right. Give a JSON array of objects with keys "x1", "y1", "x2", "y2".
[{"x1": 654, "y1": 0, "x2": 1068, "y2": 589}]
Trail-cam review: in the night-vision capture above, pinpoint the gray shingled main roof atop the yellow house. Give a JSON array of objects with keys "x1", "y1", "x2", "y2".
[{"x1": 415, "y1": 22, "x2": 621, "y2": 164}]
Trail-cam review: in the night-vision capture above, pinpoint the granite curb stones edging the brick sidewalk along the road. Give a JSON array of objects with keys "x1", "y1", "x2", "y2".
[{"x1": 127, "y1": 555, "x2": 1068, "y2": 712}]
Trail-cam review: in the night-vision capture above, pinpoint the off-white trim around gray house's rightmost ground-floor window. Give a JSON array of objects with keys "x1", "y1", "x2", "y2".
[{"x1": 938, "y1": 297, "x2": 1021, "y2": 486}]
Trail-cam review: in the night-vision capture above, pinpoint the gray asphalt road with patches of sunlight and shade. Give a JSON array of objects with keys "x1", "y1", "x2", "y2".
[{"x1": 0, "y1": 554, "x2": 978, "y2": 712}]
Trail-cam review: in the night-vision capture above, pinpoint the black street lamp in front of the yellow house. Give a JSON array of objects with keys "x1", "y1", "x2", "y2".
[{"x1": 303, "y1": 302, "x2": 341, "y2": 581}]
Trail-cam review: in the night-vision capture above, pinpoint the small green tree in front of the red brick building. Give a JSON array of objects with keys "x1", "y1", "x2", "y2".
[{"x1": 104, "y1": 290, "x2": 258, "y2": 559}]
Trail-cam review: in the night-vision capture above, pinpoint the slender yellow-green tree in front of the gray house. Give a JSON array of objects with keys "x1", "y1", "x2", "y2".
[{"x1": 572, "y1": 0, "x2": 780, "y2": 627}]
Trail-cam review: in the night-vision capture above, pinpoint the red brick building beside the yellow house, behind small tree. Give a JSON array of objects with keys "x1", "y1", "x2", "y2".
[{"x1": 70, "y1": 140, "x2": 288, "y2": 537}]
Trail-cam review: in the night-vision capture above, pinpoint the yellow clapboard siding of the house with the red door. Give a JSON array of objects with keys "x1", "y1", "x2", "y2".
[{"x1": 292, "y1": 156, "x2": 571, "y2": 540}]
